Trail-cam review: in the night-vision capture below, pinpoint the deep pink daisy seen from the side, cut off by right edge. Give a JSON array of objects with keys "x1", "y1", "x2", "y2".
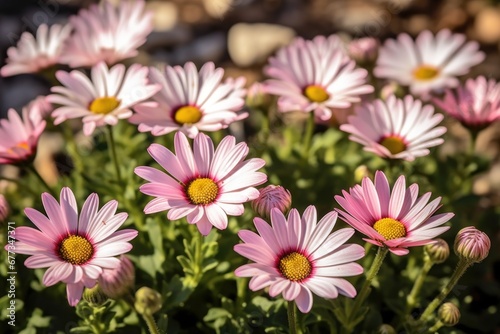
[{"x1": 433, "y1": 76, "x2": 500, "y2": 128}]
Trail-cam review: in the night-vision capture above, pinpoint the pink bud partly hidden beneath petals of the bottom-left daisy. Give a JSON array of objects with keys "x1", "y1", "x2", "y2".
[{"x1": 99, "y1": 254, "x2": 135, "y2": 299}]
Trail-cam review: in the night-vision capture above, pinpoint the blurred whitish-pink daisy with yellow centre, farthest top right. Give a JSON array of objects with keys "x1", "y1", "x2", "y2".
[{"x1": 374, "y1": 29, "x2": 485, "y2": 98}]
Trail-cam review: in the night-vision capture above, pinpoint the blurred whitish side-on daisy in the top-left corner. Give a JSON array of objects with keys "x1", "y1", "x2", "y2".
[{"x1": 0, "y1": 24, "x2": 71, "y2": 77}]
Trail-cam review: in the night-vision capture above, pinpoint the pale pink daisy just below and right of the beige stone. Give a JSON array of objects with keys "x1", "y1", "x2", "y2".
[{"x1": 264, "y1": 35, "x2": 373, "y2": 120}]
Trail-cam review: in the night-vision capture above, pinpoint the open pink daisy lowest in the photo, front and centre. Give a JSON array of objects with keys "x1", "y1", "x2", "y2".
[{"x1": 234, "y1": 205, "x2": 365, "y2": 313}]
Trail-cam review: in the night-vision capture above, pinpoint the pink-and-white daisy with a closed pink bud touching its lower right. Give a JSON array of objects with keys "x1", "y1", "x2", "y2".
[{"x1": 135, "y1": 132, "x2": 267, "y2": 235}]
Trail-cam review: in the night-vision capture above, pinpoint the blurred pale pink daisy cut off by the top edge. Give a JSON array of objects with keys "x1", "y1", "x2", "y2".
[{"x1": 61, "y1": 0, "x2": 153, "y2": 67}]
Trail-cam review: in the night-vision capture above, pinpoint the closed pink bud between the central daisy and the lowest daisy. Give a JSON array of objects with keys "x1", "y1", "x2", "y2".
[{"x1": 252, "y1": 185, "x2": 292, "y2": 219}]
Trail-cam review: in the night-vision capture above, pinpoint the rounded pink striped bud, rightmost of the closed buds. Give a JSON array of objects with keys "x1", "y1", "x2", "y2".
[{"x1": 455, "y1": 226, "x2": 491, "y2": 263}]
